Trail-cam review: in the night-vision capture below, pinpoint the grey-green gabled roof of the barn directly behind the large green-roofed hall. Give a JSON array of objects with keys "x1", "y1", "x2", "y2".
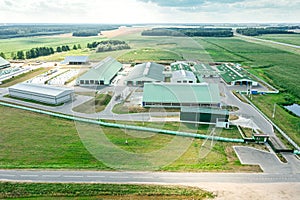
[{"x1": 126, "y1": 62, "x2": 165, "y2": 81}]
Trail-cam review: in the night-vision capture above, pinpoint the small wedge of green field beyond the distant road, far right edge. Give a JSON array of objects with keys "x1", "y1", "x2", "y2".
[{"x1": 257, "y1": 34, "x2": 300, "y2": 46}]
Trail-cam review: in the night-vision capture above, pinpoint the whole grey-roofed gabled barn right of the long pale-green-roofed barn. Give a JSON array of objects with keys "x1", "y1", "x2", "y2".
[{"x1": 125, "y1": 62, "x2": 165, "y2": 86}]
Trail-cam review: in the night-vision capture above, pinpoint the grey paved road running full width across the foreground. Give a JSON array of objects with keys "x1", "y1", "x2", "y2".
[{"x1": 0, "y1": 170, "x2": 300, "y2": 184}]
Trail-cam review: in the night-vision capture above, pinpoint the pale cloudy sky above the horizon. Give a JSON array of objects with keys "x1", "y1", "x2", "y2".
[{"x1": 0, "y1": 0, "x2": 300, "y2": 24}]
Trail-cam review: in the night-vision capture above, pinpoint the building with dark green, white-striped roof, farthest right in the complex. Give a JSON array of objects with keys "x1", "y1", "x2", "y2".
[{"x1": 217, "y1": 64, "x2": 258, "y2": 86}]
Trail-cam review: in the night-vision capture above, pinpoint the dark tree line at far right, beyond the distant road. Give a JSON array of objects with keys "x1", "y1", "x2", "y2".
[{"x1": 236, "y1": 26, "x2": 300, "y2": 36}]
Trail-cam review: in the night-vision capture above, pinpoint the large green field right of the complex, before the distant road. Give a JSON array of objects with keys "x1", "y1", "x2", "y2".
[{"x1": 199, "y1": 38, "x2": 300, "y2": 98}]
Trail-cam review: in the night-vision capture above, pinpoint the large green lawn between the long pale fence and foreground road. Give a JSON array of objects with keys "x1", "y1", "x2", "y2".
[{"x1": 0, "y1": 106, "x2": 260, "y2": 172}]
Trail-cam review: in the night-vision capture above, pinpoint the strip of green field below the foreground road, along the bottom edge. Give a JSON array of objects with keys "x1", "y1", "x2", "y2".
[{"x1": 0, "y1": 182, "x2": 215, "y2": 200}]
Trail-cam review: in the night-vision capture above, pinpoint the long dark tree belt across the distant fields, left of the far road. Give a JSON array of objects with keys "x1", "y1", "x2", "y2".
[{"x1": 142, "y1": 28, "x2": 233, "y2": 37}]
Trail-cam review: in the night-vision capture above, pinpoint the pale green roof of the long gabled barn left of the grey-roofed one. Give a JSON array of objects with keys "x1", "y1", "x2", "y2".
[{"x1": 77, "y1": 57, "x2": 123, "y2": 85}]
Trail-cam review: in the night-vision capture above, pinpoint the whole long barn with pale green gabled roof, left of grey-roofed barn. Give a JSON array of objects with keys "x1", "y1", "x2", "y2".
[{"x1": 76, "y1": 57, "x2": 123, "y2": 86}]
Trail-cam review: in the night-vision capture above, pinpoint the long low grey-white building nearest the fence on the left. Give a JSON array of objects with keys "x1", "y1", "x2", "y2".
[{"x1": 8, "y1": 83, "x2": 74, "y2": 105}]
